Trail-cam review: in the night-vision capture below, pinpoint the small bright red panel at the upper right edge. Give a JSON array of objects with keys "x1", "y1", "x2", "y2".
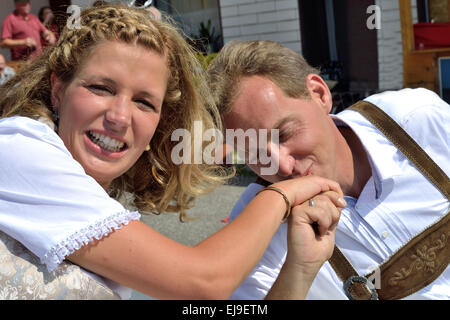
[{"x1": 414, "y1": 22, "x2": 450, "y2": 50}]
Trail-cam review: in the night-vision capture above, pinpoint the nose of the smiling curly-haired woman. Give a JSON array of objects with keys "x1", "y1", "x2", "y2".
[{"x1": 105, "y1": 96, "x2": 133, "y2": 131}]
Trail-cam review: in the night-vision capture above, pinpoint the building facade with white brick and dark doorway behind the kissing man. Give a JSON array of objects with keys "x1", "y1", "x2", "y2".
[{"x1": 219, "y1": 0, "x2": 417, "y2": 96}]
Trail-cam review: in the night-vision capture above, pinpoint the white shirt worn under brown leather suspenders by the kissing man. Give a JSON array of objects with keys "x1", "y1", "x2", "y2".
[{"x1": 230, "y1": 89, "x2": 450, "y2": 300}]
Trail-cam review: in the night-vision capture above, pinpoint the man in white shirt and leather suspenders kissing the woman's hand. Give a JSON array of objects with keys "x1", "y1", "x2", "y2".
[{"x1": 208, "y1": 41, "x2": 450, "y2": 299}]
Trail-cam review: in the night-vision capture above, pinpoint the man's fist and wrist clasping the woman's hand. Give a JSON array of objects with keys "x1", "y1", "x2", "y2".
[{"x1": 266, "y1": 191, "x2": 346, "y2": 299}]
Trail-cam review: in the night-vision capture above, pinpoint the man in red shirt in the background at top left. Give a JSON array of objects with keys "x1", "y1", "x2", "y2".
[{"x1": 0, "y1": 0, "x2": 55, "y2": 61}]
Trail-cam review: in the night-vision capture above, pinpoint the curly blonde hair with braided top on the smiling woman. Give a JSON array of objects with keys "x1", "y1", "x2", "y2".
[{"x1": 0, "y1": 4, "x2": 230, "y2": 220}]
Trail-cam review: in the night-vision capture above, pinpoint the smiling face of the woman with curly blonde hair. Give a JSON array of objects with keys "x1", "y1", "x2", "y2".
[{"x1": 52, "y1": 41, "x2": 169, "y2": 189}]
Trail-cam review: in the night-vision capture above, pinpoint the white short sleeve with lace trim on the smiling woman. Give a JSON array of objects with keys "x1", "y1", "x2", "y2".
[{"x1": 0, "y1": 117, "x2": 140, "y2": 298}]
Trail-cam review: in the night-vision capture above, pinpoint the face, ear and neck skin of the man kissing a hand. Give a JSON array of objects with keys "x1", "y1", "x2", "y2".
[{"x1": 225, "y1": 74, "x2": 371, "y2": 197}]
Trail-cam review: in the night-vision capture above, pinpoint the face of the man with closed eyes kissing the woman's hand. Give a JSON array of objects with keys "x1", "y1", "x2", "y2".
[{"x1": 225, "y1": 75, "x2": 336, "y2": 183}]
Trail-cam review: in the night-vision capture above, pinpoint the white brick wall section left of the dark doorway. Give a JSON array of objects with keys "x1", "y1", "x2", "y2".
[{"x1": 220, "y1": 0, "x2": 301, "y2": 53}]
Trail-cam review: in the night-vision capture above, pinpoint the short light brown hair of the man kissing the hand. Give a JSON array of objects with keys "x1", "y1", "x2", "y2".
[{"x1": 207, "y1": 41, "x2": 319, "y2": 115}]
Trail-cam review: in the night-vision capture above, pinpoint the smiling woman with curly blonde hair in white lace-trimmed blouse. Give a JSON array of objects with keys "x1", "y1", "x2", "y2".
[{"x1": 0, "y1": 5, "x2": 342, "y2": 299}]
